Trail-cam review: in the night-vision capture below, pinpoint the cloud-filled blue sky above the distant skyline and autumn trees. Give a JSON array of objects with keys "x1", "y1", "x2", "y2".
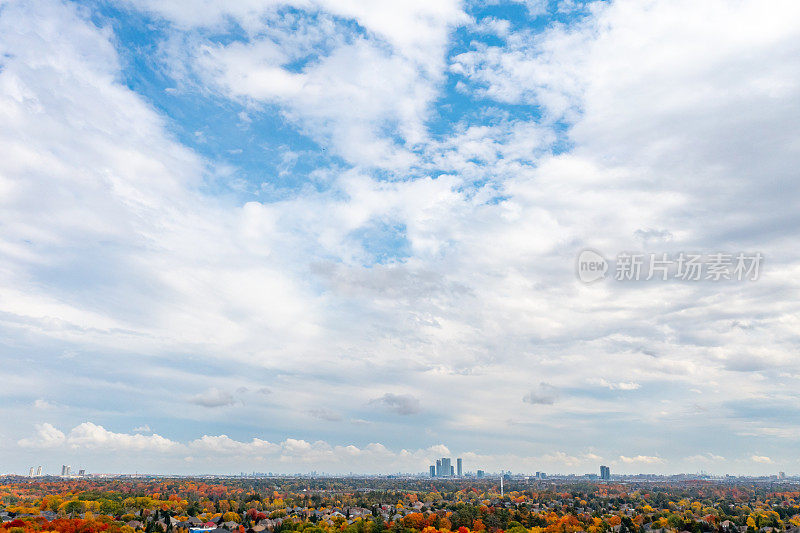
[{"x1": 0, "y1": 0, "x2": 800, "y2": 475}]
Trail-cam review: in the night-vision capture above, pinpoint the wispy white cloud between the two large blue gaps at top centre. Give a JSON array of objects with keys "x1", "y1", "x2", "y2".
[{"x1": 139, "y1": 0, "x2": 468, "y2": 167}]
